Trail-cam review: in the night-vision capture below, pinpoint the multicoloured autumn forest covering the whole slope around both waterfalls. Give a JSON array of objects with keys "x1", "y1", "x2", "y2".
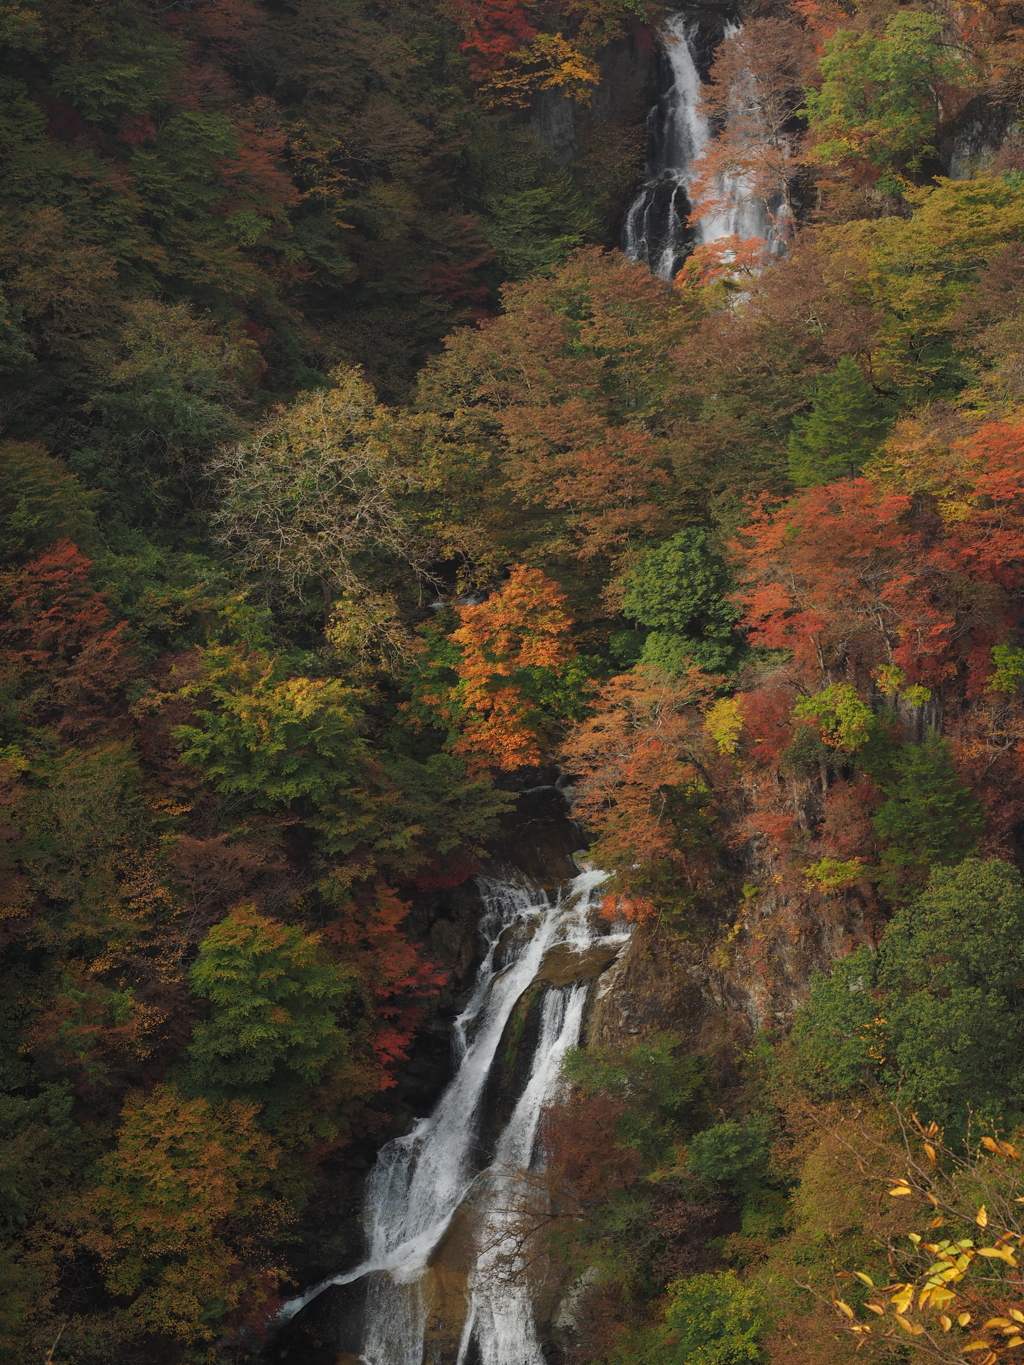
[{"x1": 0, "y1": 0, "x2": 1024, "y2": 1365}]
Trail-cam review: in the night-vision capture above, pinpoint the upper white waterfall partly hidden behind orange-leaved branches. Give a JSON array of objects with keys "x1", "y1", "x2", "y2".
[{"x1": 623, "y1": 12, "x2": 773, "y2": 280}]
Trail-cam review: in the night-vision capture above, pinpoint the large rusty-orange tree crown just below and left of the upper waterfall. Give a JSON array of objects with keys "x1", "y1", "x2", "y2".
[{"x1": 419, "y1": 247, "x2": 698, "y2": 589}]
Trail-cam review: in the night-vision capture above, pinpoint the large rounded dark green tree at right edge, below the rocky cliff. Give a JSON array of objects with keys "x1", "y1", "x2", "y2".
[{"x1": 793, "y1": 859, "x2": 1024, "y2": 1140}]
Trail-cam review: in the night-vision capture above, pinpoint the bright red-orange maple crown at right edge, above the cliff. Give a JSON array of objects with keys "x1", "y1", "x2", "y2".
[{"x1": 736, "y1": 455, "x2": 1024, "y2": 687}]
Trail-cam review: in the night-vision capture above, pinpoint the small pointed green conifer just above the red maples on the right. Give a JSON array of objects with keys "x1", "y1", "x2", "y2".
[{"x1": 789, "y1": 355, "x2": 887, "y2": 487}]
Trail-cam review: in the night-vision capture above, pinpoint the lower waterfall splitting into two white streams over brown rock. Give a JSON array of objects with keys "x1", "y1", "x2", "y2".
[{"x1": 281, "y1": 871, "x2": 628, "y2": 1365}]
